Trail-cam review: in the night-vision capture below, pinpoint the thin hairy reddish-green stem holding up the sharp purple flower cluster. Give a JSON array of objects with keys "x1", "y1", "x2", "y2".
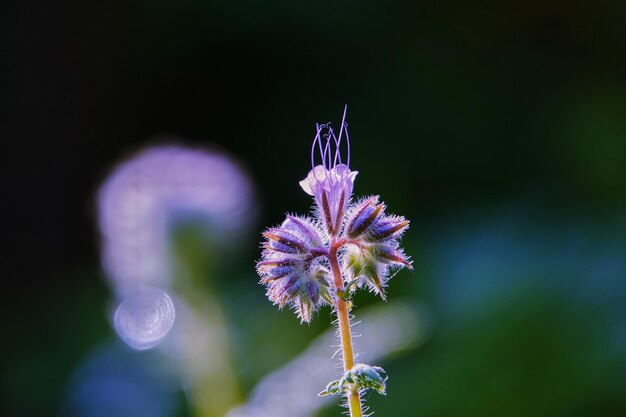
[{"x1": 328, "y1": 241, "x2": 363, "y2": 417}]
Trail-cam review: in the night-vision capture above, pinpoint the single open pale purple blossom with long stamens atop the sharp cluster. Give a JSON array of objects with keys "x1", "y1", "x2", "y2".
[{"x1": 300, "y1": 110, "x2": 358, "y2": 236}]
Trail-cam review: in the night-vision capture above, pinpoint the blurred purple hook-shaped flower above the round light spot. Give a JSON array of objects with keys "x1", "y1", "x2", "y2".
[{"x1": 98, "y1": 145, "x2": 253, "y2": 294}]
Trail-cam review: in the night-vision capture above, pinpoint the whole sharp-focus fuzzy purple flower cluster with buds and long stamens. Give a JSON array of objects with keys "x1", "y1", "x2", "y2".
[{"x1": 257, "y1": 108, "x2": 412, "y2": 322}]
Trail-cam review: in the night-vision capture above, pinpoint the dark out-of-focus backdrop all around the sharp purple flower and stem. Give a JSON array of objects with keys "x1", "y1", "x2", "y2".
[{"x1": 0, "y1": 0, "x2": 626, "y2": 417}]
